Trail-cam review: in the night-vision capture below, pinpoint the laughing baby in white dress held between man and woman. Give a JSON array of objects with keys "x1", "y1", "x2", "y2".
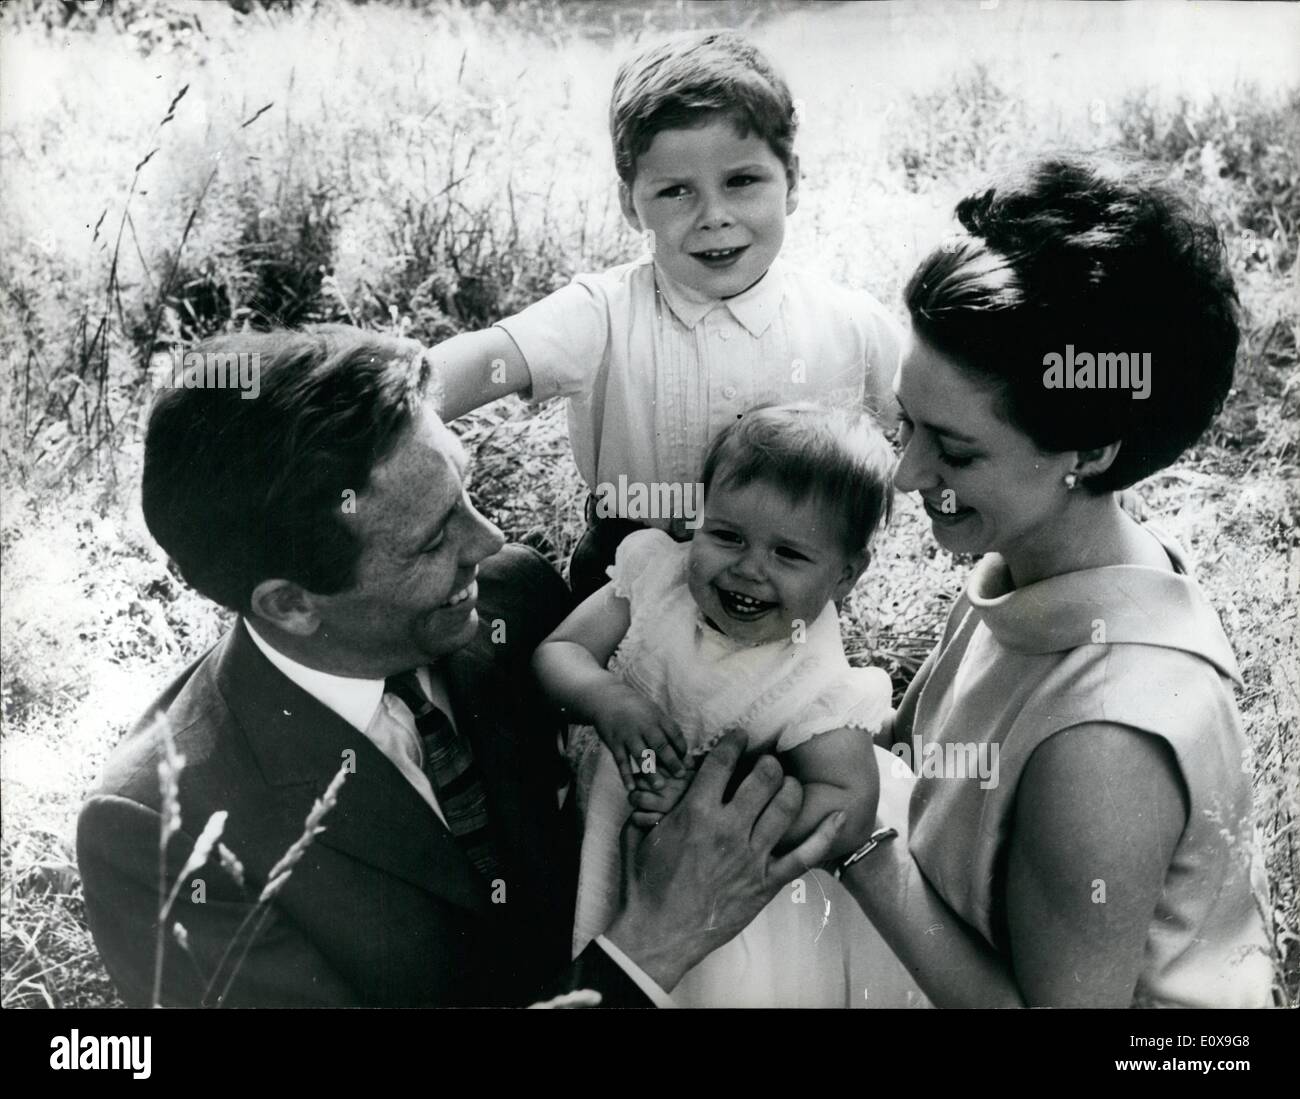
[{"x1": 534, "y1": 404, "x2": 909, "y2": 1007}]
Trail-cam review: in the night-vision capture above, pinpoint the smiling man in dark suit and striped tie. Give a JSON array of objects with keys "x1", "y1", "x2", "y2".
[{"x1": 78, "y1": 326, "x2": 837, "y2": 1007}]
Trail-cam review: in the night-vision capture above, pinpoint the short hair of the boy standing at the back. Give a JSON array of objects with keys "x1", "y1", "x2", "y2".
[{"x1": 610, "y1": 31, "x2": 797, "y2": 185}]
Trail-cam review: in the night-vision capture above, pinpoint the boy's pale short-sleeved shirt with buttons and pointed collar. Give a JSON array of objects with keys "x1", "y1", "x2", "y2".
[{"x1": 499, "y1": 256, "x2": 902, "y2": 517}]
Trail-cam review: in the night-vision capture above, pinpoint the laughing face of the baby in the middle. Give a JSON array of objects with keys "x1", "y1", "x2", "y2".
[{"x1": 689, "y1": 481, "x2": 867, "y2": 644}]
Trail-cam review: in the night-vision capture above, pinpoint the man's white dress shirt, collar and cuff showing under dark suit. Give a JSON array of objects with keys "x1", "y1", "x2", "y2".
[{"x1": 241, "y1": 618, "x2": 673, "y2": 1008}]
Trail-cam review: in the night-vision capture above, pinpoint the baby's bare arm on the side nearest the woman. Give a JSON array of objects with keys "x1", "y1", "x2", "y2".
[{"x1": 781, "y1": 728, "x2": 880, "y2": 857}]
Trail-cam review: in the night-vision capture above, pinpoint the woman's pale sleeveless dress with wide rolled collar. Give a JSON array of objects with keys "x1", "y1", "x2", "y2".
[{"x1": 899, "y1": 528, "x2": 1273, "y2": 1007}]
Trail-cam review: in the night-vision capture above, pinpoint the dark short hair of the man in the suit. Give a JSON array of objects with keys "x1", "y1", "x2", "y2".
[{"x1": 143, "y1": 325, "x2": 429, "y2": 613}]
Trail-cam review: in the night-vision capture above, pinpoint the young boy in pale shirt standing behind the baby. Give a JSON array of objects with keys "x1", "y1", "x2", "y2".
[{"x1": 429, "y1": 31, "x2": 901, "y2": 598}]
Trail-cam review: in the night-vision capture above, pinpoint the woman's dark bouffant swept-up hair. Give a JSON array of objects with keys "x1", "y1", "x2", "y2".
[{"x1": 905, "y1": 157, "x2": 1238, "y2": 493}]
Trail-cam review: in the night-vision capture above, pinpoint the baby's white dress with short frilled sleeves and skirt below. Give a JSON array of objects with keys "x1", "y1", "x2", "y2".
[{"x1": 572, "y1": 529, "x2": 926, "y2": 1007}]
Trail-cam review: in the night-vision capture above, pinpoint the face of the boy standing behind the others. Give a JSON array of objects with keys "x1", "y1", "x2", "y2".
[{"x1": 619, "y1": 116, "x2": 798, "y2": 298}]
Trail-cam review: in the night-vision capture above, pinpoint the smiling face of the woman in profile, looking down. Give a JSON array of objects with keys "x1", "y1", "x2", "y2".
[{"x1": 894, "y1": 334, "x2": 1083, "y2": 558}]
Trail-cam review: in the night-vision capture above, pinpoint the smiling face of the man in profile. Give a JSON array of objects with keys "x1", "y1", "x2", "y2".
[{"x1": 315, "y1": 408, "x2": 504, "y2": 678}]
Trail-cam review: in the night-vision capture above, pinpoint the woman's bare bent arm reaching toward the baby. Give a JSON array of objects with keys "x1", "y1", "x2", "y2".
[{"x1": 844, "y1": 723, "x2": 1187, "y2": 1007}]
